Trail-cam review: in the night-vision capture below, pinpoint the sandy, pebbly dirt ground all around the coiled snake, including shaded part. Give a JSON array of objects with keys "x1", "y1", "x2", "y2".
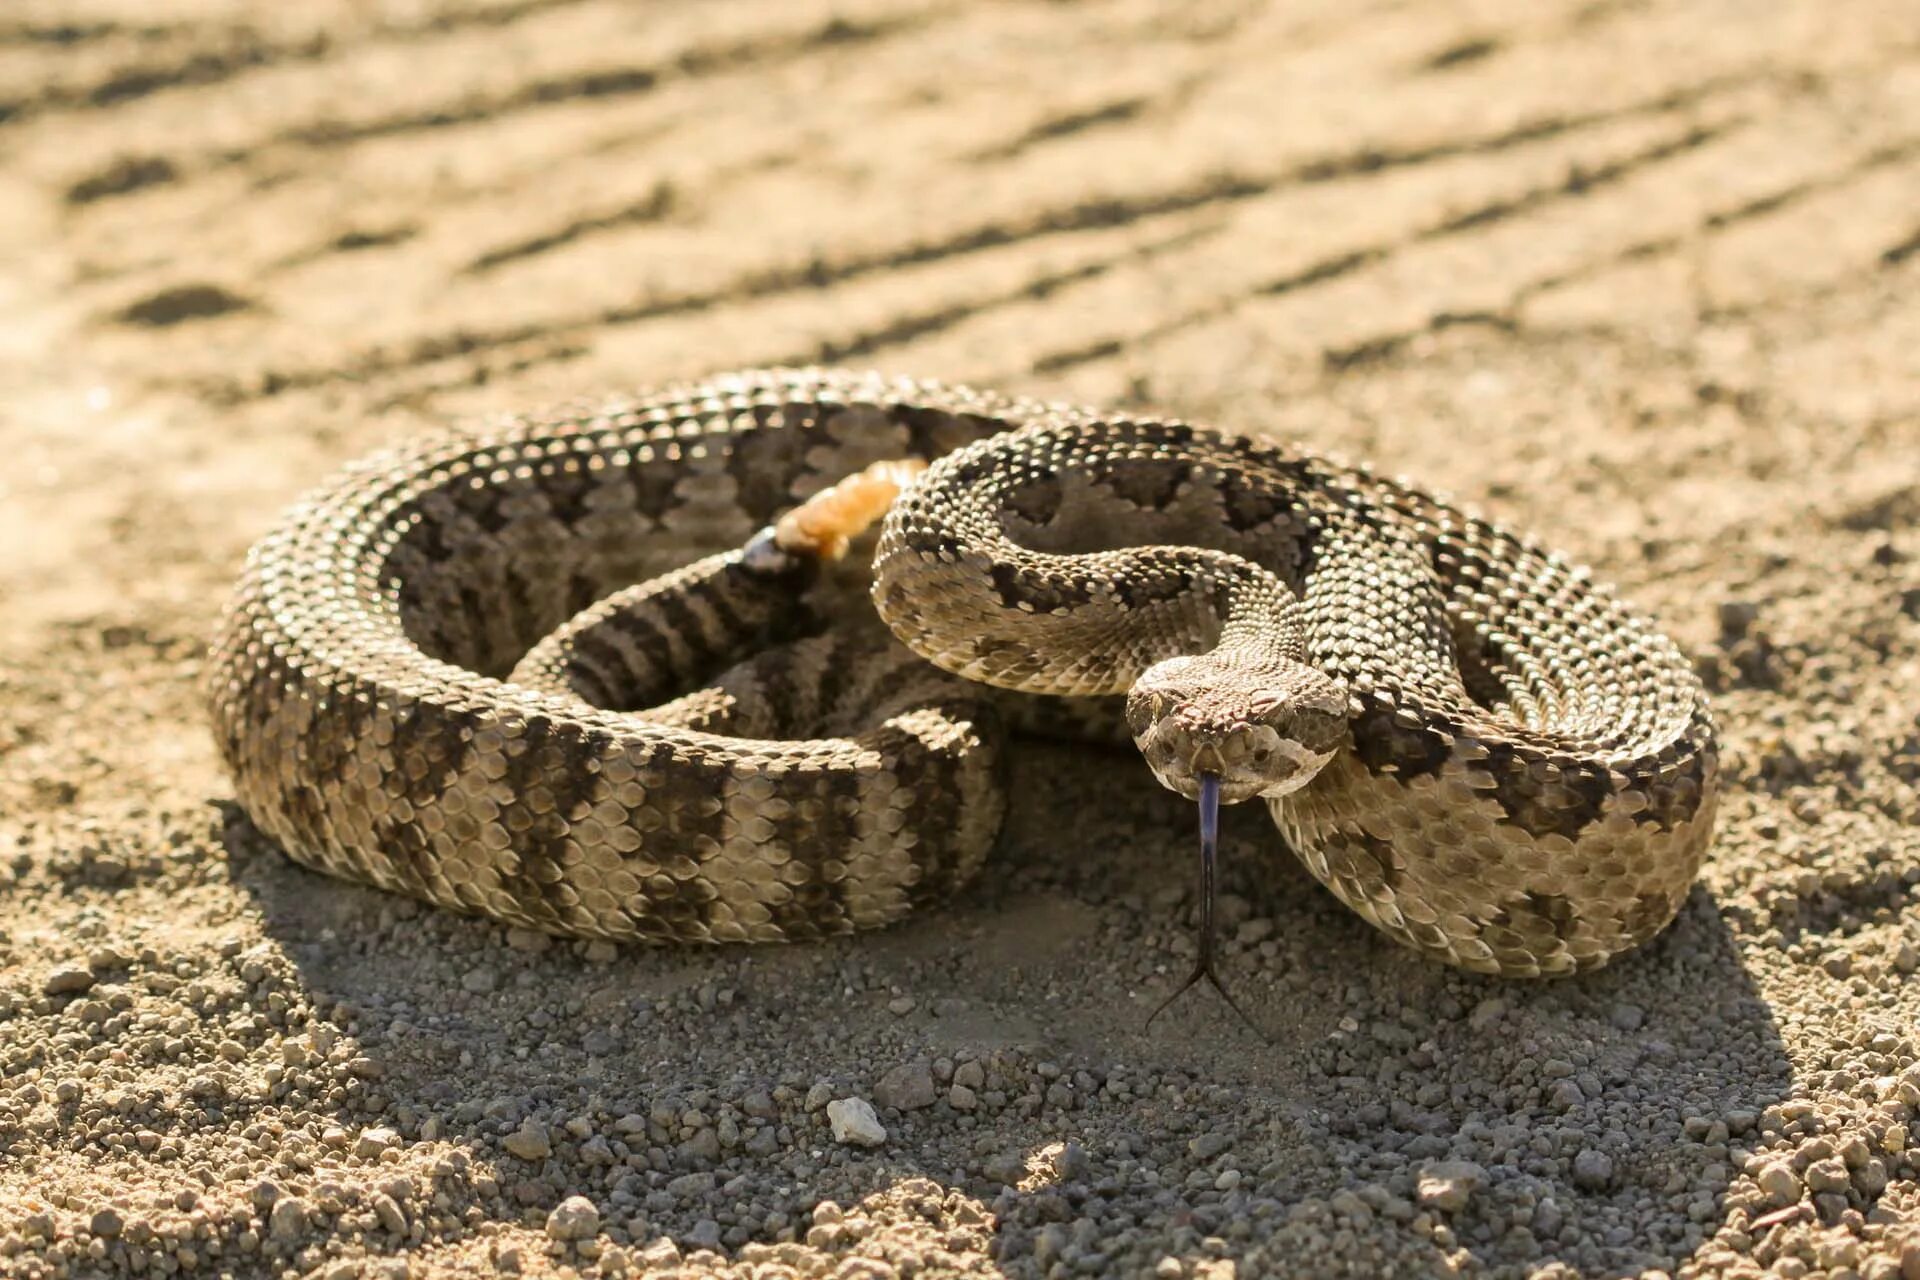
[{"x1": 0, "y1": 0, "x2": 1920, "y2": 1280}]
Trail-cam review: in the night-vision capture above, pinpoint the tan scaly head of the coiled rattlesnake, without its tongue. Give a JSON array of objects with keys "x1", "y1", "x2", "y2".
[{"x1": 1127, "y1": 652, "x2": 1346, "y2": 804}]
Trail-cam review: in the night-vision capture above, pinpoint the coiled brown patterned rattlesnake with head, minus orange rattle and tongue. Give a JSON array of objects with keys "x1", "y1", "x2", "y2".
[{"x1": 211, "y1": 368, "x2": 1716, "y2": 975}]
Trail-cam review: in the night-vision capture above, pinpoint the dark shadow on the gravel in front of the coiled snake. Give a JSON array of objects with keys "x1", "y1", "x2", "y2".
[{"x1": 225, "y1": 743, "x2": 1793, "y2": 1276}]
